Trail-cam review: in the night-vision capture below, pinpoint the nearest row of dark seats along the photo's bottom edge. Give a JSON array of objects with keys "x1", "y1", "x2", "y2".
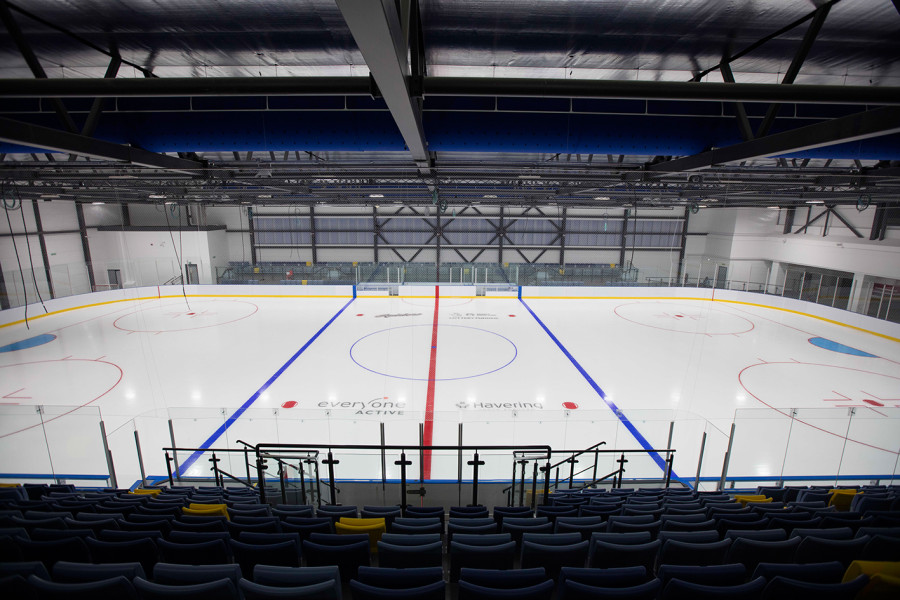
[{"x1": 0, "y1": 562, "x2": 888, "y2": 600}]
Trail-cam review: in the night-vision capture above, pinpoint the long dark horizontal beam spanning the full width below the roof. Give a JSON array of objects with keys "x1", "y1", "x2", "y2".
[{"x1": 0, "y1": 76, "x2": 900, "y2": 106}]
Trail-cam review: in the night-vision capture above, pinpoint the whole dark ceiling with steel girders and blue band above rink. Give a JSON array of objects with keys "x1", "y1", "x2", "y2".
[{"x1": 0, "y1": 0, "x2": 900, "y2": 208}]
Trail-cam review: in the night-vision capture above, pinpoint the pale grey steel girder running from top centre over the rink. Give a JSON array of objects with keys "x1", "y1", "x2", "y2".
[{"x1": 337, "y1": 0, "x2": 429, "y2": 165}]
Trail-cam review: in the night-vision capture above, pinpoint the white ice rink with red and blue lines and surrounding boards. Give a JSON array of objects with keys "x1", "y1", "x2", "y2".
[{"x1": 0, "y1": 286, "x2": 900, "y2": 485}]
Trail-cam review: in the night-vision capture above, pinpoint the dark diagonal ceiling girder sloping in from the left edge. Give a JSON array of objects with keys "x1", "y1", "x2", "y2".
[{"x1": 0, "y1": 117, "x2": 206, "y2": 175}]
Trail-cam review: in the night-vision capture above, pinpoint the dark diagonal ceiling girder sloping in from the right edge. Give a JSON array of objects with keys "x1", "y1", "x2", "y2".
[{"x1": 647, "y1": 106, "x2": 900, "y2": 173}]
